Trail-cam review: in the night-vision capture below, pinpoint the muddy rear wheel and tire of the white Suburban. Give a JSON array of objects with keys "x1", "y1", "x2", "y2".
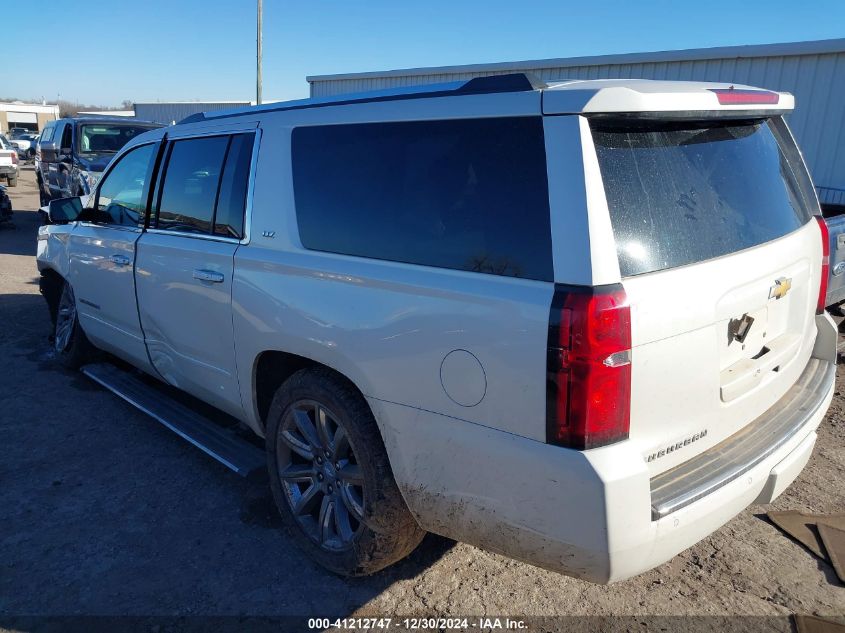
[{"x1": 266, "y1": 368, "x2": 425, "y2": 576}]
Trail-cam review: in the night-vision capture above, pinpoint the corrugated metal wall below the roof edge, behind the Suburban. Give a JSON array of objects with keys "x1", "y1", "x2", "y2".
[{"x1": 311, "y1": 50, "x2": 845, "y2": 204}]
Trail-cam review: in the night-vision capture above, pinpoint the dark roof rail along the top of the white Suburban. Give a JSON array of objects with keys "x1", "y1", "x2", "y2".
[{"x1": 179, "y1": 73, "x2": 547, "y2": 124}]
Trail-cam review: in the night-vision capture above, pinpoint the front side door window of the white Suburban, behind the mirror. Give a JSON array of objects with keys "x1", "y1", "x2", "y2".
[{"x1": 95, "y1": 143, "x2": 156, "y2": 227}]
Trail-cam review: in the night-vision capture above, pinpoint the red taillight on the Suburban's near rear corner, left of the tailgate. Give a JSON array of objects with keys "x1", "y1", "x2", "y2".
[{"x1": 546, "y1": 284, "x2": 631, "y2": 449}]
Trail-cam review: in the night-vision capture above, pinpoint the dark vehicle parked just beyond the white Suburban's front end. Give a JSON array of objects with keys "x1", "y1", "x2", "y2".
[{"x1": 36, "y1": 117, "x2": 161, "y2": 205}]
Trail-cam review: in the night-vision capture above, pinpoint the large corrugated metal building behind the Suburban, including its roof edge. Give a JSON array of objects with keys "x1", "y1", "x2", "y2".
[{"x1": 307, "y1": 39, "x2": 845, "y2": 205}]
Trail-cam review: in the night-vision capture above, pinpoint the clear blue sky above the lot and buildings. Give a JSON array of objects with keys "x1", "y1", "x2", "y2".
[{"x1": 8, "y1": 0, "x2": 845, "y2": 105}]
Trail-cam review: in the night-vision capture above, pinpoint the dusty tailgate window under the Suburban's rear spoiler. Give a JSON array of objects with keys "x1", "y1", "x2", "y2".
[{"x1": 591, "y1": 121, "x2": 810, "y2": 277}]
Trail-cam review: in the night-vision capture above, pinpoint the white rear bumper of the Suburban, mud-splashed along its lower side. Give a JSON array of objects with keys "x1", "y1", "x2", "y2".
[{"x1": 370, "y1": 315, "x2": 836, "y2": 583}]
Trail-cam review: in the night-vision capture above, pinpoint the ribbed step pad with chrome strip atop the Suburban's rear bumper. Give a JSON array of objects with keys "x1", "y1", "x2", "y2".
[{"x1": 651, "y1": 358, "x2": 836, "y2": 521}]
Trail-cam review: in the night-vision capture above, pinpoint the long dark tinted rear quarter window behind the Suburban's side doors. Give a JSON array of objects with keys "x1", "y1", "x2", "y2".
[{"x1": 292, "y1": 117, "x2": 553, "y2": 280}]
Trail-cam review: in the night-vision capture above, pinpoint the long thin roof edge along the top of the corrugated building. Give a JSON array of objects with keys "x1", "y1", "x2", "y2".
[{"x1": 305, "y1": 38, "x2": 845, "y2": 83}]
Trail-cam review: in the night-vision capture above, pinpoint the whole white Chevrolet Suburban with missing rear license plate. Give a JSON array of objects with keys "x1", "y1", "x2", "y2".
[{"x1": 38, "y1": 74, "x2": 837, "y2": 583}]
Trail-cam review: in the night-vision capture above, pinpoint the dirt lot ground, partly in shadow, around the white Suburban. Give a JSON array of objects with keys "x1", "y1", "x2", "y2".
[{"x1": 0, "y1": 168, "x2": 845, "y2": 630}]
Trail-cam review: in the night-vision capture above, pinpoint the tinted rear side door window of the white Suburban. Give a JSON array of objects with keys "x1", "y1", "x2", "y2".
[{"x1": 156, "y1": 134, "x2": 253, "y2": 238}]
